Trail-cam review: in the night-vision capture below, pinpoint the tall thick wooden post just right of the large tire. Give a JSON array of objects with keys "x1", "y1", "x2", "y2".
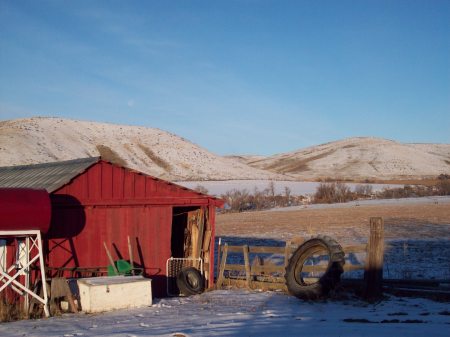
[{"x1": 364, "y1": 217, "x2": 384, "y2": 301}]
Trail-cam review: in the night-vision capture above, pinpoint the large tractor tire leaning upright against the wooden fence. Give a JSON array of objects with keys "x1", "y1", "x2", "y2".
[{"x1": 285, "y1": 236, "x2": 345, "y2": 299}]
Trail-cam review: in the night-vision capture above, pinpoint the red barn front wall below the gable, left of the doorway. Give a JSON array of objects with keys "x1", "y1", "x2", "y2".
[{"x1": 48, "y1": 202, "x2": 172, "y2": 296}]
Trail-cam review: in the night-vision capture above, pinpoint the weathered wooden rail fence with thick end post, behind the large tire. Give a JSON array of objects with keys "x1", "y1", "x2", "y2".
[{"x1": 216, "y1": 218, "x2": 384, "y2": 298}]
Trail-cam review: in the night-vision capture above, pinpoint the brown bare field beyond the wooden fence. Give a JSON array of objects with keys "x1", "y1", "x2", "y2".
[{"x1": 216, "y1": 198, "x2": 450, "y2": 244}]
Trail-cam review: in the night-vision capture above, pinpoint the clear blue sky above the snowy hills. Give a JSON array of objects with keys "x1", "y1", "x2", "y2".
[{"x1": 0, "y1": 0, "x2": 450, "y2": 155}]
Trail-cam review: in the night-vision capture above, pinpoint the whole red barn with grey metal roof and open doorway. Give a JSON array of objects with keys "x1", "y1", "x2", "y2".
[{"x1": 0, "y1": 158, "x2": 223, "y2": 296}]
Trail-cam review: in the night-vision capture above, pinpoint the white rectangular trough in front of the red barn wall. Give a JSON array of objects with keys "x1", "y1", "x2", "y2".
[{"x1": 77, "y1": 276, "x2": 152, "y2": 313}]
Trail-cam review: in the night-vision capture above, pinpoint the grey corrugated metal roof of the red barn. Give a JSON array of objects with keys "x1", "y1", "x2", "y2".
[{"x1": 0, "y1": 157, "x2": 100, "y2": 193}]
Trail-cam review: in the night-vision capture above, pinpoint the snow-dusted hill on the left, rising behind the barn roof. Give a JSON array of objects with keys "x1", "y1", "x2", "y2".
[{"x1": 0, "y1": 117, "x2": 280, "y2": 180}]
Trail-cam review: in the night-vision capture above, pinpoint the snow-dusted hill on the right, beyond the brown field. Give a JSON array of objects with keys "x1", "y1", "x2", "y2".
[{"x1": 247, "y1": 137, "x2": 450, "y2": 180}]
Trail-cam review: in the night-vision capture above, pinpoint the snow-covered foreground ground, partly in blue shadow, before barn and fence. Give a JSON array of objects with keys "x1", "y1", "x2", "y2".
[{"x1": 0, "y1": 290, "x2": 450, "y2": 337}]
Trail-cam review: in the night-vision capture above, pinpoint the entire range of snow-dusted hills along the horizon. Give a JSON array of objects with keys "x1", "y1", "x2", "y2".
[{"x1": 0, "y1": 117, "x2": 450, "y2": 181}]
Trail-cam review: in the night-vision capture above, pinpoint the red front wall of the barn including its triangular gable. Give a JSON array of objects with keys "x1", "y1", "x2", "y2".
[{"x1": 47, "y1": 161, "x2": 221, "y2": 296}]
